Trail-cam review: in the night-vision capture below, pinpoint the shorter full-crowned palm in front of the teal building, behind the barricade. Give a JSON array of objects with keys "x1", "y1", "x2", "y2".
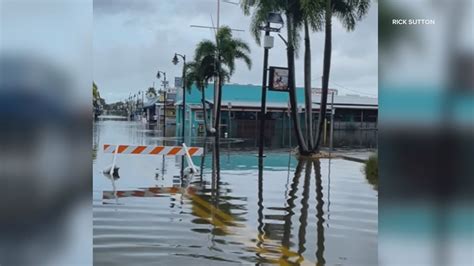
[{"x1": 194, "y1": 26, "x2": 252, "y2": 137}]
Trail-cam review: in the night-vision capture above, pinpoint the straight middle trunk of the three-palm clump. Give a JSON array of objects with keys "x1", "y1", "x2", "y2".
[{"x1": 304, "y1": 20, "x2": 314, "y2": 151}]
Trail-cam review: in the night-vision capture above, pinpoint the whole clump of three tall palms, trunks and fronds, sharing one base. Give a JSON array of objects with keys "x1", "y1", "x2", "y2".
[{"x1": 242, "y1": 0, "x2": 370, "y2": 155}]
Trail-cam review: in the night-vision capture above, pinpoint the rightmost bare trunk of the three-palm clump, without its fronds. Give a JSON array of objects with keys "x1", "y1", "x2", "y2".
[{"x1": 316, "y1": 0, "x2": 332, "y2": 150}]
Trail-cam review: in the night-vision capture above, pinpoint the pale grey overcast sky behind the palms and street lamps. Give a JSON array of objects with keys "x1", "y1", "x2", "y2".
[{"x1": 93, "y1": 0, "x2": 378, "y2": 102}]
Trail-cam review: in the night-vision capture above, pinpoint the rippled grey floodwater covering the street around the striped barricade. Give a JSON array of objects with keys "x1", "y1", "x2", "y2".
[{"x1": 93, "y1": 120, "x2": 378, "y2": 265}]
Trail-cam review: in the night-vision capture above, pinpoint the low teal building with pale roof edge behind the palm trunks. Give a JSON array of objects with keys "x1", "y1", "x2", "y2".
[{"x1": 175, "y1": 84, "x2": 378, "y2": 137}]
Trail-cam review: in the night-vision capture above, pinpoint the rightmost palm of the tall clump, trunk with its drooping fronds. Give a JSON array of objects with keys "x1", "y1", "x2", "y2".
[{"x1": 315, "y1": 0, "x2": 370, "y2": 150}]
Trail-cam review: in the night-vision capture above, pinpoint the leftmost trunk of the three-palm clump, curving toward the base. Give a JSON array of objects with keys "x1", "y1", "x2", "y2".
[{"x1": 286, "y1": 11, "x2": 309, "y2": 155}]
